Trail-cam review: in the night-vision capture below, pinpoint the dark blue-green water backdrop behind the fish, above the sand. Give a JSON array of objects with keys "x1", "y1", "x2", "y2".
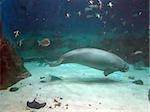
[{"x1": 2, "y1": 0, "x2": 149, "y2": 65}]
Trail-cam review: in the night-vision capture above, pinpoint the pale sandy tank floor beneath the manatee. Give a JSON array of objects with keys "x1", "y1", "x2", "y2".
[{"x1": 0, "y1": 63, "x2": 150, "y2": 112}]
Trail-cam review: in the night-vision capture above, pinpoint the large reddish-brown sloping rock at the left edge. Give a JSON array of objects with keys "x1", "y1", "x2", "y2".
[{"x1": 0, "y1": 34, "x2": 30, "y2": 89}]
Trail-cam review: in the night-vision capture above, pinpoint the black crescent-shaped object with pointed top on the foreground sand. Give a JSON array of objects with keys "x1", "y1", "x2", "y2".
[{"x1": 27, "y1": 99, "x2": 46, "y2": 109}]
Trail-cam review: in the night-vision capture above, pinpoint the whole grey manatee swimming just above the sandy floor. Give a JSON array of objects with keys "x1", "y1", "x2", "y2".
[{"x1": 47, "y1": 48, "x2": 129, "y2": 76}]
